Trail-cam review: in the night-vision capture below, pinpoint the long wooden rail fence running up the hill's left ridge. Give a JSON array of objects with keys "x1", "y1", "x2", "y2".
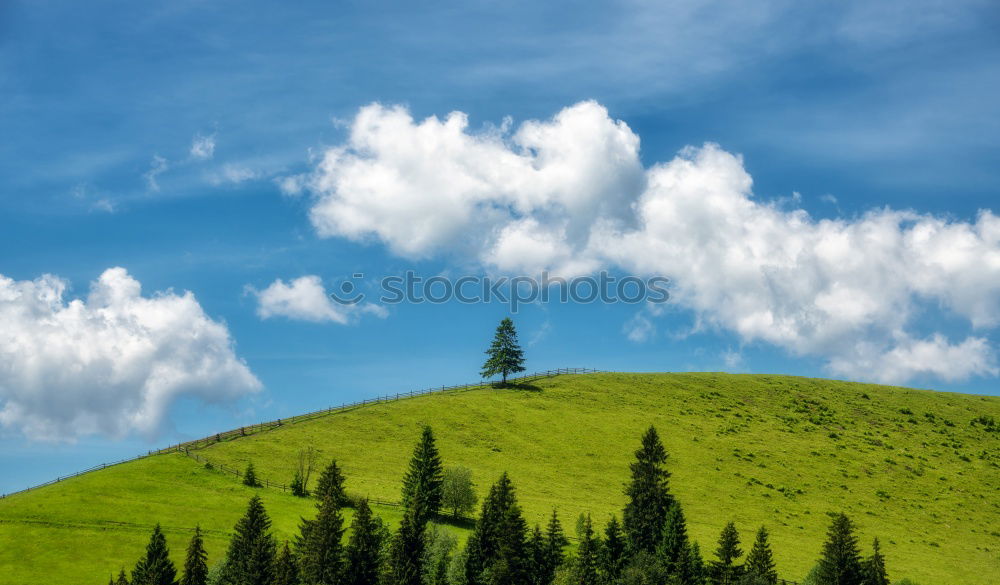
[{"x1": 0, "y1": 368, "x2": 603, "y2": 498}]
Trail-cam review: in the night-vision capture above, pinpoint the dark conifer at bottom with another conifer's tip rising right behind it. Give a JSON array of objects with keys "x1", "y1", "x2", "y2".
[{"x1": 299, "y1": 494, "x2": 344, "y2": 585}]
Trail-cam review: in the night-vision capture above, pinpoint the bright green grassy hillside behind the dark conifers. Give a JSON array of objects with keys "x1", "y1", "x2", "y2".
[{"x1": 0, "y1": 374, "x2": 1000, "y2": 585}]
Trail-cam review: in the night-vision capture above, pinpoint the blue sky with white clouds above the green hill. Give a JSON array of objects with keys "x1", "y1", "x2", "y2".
[{"x1": 0, "y1": 0, "x2": 1000, "y2": 491}]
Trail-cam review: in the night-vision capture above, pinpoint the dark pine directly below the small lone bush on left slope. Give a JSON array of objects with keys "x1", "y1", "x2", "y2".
[{"x1": 221, "y1": 496, "x2": 277, "y2": 585}]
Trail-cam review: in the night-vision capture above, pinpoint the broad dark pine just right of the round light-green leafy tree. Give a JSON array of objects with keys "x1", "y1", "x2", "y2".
[{"x1": 465, "y1": 473, "x2": 528, "y2": 585}]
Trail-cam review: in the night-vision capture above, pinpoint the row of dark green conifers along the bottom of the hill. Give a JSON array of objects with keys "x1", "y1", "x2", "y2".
[{"x1": 110, "y1": 427, "x2": 889, "y2": 585}]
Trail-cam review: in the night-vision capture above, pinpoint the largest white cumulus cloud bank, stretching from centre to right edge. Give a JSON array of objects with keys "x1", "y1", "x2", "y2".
[{"x1": 291, "y1": 102, "x2": 1000, "y2": 381}]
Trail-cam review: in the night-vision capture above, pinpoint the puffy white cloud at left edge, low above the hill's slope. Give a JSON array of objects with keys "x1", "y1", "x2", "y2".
[{"x1": 0, "y1": 268, "x2": 261, "y2": 440}]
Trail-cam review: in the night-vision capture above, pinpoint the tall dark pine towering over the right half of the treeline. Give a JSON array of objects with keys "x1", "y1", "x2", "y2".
[{"x1": 622, "y1": 427, "x2": 673, "y2": 554}]
